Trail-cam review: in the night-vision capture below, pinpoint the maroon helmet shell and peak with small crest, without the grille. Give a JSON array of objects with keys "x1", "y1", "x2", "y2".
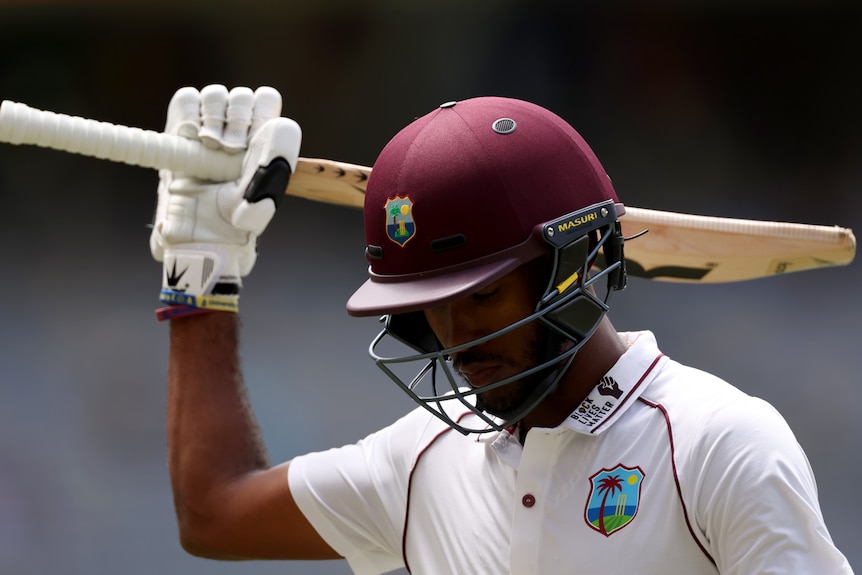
[{"x1": 347, "y1": 97, "x2": 619, "y2": 316}]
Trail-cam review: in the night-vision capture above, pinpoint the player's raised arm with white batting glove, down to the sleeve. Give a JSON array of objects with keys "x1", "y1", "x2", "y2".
[{"x1": 150, "y1": 86, "x2": 337, "y2": 559}]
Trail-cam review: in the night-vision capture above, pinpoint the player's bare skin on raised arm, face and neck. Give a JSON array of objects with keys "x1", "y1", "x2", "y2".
[{"x1": 167, "y1": 266, "x2": 625, "y2": 560}]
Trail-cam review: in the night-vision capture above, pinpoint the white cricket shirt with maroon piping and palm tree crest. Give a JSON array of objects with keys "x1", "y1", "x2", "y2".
[{"x1": 288, "y1": 332, "x2": 852, "y2": 575}]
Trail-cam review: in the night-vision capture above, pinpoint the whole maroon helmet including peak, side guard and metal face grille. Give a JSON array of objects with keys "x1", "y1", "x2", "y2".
[{"x1": 347, "y1": 97, "x2": 625, "y2": 433}]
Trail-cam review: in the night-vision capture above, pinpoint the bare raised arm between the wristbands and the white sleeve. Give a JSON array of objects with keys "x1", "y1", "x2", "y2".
[{"x1": 167, "y1": 313, "x2": 339, "y2": 559}]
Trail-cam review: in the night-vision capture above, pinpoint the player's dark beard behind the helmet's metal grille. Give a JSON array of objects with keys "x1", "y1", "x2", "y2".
[{"x1": 456, "y1": 326, "x2": 573, "y2": 423}]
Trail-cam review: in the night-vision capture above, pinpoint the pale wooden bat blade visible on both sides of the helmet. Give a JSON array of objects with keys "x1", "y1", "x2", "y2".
[{"x1": 287, "y1": 158, "x2": 856, "y2": 283}]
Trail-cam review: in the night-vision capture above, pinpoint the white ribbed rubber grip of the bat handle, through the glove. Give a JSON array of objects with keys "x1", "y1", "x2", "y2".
[{"x1": 0, "y1": 100, "x2": 243, "y2": 180}]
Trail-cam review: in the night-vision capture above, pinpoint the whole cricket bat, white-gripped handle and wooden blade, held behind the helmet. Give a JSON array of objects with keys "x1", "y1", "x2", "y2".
[{"x1": 0, "y1": 100, "x2": 856, "y2": 283}]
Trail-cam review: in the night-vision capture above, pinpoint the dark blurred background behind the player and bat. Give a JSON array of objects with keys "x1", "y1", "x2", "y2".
[{"x1": 0, "y1": 0, "x2": 862, "y2": 575}]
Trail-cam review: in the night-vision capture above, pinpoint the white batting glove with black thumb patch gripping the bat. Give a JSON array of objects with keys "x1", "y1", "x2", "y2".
[{"x1": 150, "y1": 85, "x2": 302, "y2": 319}]
